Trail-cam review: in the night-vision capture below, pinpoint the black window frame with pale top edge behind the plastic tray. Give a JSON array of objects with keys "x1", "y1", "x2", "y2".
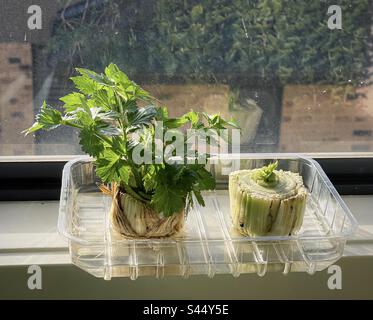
[{"x1": 0, "y1": 152, "x2": 373, "y2": 201}]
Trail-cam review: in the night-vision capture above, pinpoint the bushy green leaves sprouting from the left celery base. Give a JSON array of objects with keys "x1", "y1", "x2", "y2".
[{"x1": 24, "y1": 64, "x2": 237, "y2": 216}]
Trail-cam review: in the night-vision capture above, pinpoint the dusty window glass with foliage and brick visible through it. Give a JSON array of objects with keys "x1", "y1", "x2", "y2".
[{"x1": 0, "y1": 0, "x2": 373, "y2": 155}]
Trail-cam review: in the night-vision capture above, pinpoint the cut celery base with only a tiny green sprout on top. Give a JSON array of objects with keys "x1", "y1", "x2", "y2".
[{"x1": 229, "y1": 164, "x2": 307, "y2": 236}]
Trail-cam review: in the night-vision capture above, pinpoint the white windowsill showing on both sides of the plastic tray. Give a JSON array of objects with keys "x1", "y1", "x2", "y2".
[{"x1": 0, "y1": 196, "x2": 373, "y2": 266}]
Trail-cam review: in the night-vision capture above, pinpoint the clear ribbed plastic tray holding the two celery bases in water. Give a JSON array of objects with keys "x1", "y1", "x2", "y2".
[{"x1": 58, "y1": 154, "x2": 356, "y2": 280}]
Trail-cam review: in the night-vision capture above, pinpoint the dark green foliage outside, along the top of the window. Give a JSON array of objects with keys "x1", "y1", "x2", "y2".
[{"x1": 49, "y1": 0, "x2": 372, "y2": 84}]
